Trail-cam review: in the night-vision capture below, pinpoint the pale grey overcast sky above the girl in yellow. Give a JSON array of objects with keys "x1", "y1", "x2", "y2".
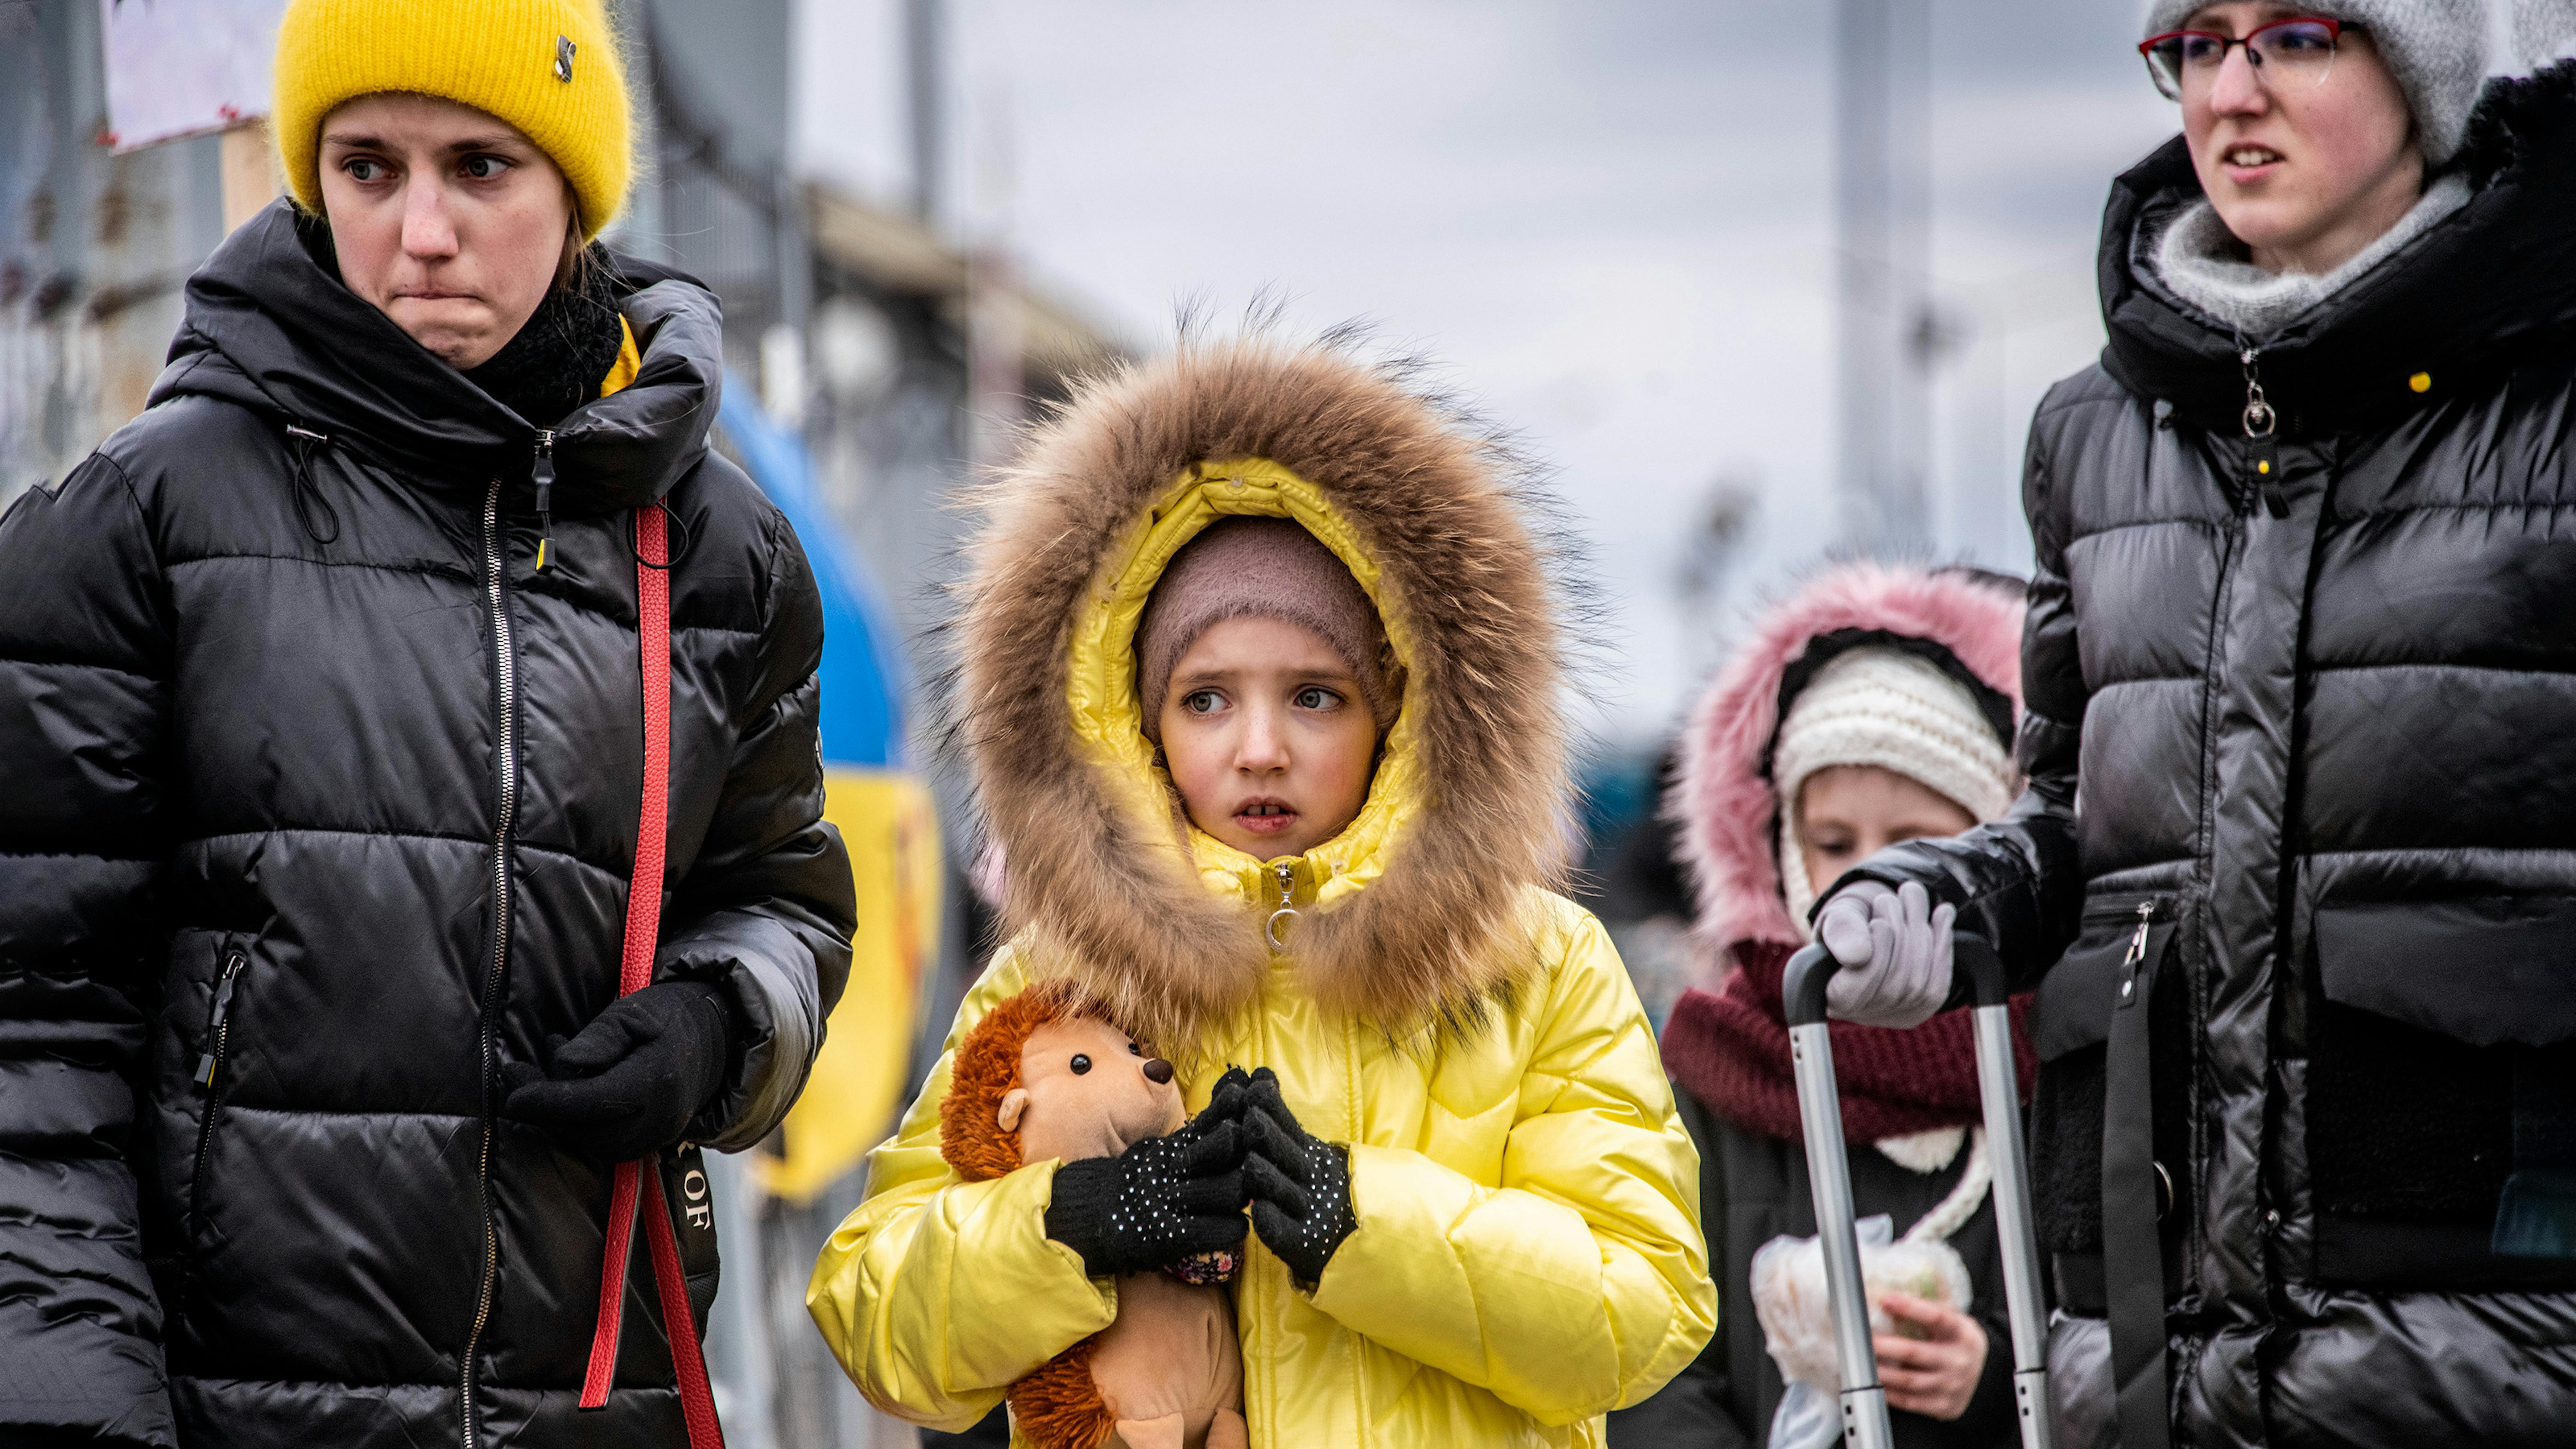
[{"x1": 796, "y1": 0, "x2": 2177, "y2": 741}]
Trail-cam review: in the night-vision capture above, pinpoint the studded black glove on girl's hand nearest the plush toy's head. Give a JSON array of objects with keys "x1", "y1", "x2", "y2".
[{"x1": 1046, "y1": 1068, "x2": 1249, "y2": 1277}]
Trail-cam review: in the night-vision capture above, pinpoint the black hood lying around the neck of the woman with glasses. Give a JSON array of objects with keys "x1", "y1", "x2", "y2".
[{"x1": 2099, "y1": 64, "x2": 2576, "y2": 438}]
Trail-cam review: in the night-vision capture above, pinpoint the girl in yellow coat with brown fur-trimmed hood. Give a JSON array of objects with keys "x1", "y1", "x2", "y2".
[{"x1": 806, "y1": 342, "x2": 1716, "y2": 1449}]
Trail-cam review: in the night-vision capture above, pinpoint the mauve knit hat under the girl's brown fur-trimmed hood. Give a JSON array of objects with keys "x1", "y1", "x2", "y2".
[{"x1": 1136, "y1": 517, "x2": 1396, "y2": 744}]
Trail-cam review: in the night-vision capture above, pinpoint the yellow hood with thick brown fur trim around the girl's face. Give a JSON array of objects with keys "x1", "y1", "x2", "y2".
[{"x1": 956, "y1": 340, "x2": 1566, "y2": 1055}]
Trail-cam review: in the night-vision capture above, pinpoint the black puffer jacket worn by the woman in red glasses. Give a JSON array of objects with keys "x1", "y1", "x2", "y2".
[{"x1": 1860, "y1": 75, "x2": 2576, "y2": 1446}]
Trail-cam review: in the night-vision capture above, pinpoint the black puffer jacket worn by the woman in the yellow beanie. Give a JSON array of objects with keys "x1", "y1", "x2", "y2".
[{"x1": 0, "y1": 203, "x2": 853, "y2": 1449}]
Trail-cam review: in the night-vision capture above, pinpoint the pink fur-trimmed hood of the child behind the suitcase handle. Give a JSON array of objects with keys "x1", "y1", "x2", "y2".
[{"x1": 1664, "y1": 564, "x2": 2022, "y2": 952}]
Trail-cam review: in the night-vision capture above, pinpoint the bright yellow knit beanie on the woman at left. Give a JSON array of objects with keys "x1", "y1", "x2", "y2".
[{"x1": 270, "y1": 0, "x2": 634, "y2": 242}]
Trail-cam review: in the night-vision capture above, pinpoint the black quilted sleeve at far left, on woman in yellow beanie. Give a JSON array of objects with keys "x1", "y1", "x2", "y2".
[{"x1": 0, "y1": 456, "x2": 173, "y2": 1444}]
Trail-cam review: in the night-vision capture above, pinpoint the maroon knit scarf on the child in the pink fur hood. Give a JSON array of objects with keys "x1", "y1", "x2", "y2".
[{"x1": 1664, "y1": 942, "x2": 2040, "y2": 1143}]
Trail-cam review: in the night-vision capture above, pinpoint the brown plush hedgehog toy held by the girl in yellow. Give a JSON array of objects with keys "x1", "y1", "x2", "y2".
[{"x1": 940, "y1": 986, "x2": 1249, "y2": 1449}]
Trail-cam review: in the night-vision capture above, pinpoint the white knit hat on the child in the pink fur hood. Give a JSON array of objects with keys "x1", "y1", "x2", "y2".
[{"x1": 1772, "y1": 649, "x2": 2020, "y2": 934}]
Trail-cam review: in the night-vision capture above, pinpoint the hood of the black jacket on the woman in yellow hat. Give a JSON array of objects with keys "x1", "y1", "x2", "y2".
[{"x1": 152, "y1": 201, "x2": 724, "y2": 515}]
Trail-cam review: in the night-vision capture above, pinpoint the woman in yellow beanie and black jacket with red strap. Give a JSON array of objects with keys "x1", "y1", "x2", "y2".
[{"x1": 0, "y1": 0, "x2": 855, "y2": 1449}]
